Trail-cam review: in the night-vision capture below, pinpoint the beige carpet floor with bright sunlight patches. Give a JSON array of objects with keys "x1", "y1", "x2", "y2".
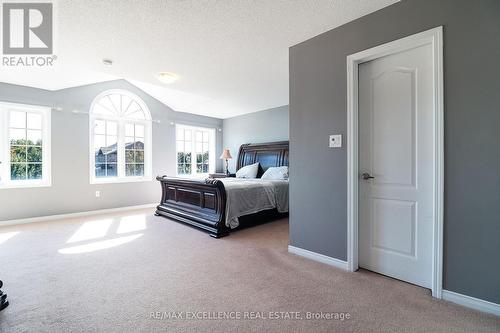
[{"x1": 0, "y1": 211, "x2": 500, "y2": 332}]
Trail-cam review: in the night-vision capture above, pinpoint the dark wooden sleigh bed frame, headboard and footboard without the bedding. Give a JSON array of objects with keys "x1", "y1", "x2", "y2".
[{"x1": 156, "y1": 141, "x2": 289, "y2": 238}]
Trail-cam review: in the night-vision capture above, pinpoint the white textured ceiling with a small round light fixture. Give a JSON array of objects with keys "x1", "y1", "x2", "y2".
[{"x1": 0, "y1": 0, "x2": 398, "y2": 118}]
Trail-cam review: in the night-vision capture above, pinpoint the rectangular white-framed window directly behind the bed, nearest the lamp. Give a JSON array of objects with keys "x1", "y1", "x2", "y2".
[{"x1": 176, "y1": 125, "x2": 215, "y2": 176}]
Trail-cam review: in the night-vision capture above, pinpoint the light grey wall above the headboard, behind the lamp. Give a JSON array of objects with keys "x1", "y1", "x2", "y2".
[{"x1": 222, "y1": 105, "x2": 289, "y2": 173}]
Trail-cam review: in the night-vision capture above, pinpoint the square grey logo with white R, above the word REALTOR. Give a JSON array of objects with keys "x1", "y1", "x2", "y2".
[{"x1": 2, "y1": 3, "x2": 53, "y2": 54}]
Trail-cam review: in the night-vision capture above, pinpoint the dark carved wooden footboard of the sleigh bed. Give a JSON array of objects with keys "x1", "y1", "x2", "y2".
[{"x1": 156, "y1": 176, "x2": 229, "y2": 238}]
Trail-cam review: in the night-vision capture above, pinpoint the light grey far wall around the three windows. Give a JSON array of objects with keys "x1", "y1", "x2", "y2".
[{"x1": 0, "y1": 80, "x2": 222, "y2": 221}]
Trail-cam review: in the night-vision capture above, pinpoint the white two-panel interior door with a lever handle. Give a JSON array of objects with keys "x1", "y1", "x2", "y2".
[{"x1": 359, "y1": 44, "x2": 435, "y2": 288}]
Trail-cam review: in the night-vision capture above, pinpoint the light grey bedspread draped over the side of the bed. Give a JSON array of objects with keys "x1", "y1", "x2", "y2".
[{"x1": 219, "y1": 178, "x2": 288, "y2": 229}]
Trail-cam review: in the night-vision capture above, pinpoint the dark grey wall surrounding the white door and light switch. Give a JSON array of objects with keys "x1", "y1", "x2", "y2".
[{"x1": 290, "y1": 0, "x2": 500, "y2": 303}]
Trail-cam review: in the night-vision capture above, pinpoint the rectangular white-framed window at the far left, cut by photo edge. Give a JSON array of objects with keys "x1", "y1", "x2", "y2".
[{"x1": 0, "y1": 103, "x2": 50, "y2": 188}]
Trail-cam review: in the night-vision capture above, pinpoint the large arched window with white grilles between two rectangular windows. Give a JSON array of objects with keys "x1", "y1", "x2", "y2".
[{"x1": 89, "y1": 90, "x2": 152, "y2": 183}]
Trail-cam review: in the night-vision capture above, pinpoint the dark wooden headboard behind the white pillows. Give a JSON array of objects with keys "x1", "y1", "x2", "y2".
[{"x1": 236, "y1": 141, "x2": 289, "y2": 178}]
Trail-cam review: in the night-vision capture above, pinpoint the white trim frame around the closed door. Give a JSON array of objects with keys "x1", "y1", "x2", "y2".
[{"x1": 347, "y1": 26, "x2": 444, "y2": 298}]
